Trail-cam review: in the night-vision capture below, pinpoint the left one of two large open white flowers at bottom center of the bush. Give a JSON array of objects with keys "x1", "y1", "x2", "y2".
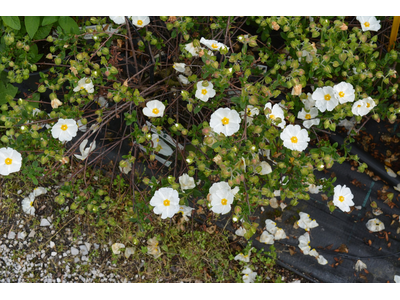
[{"x1": 150, "y1": 188, "x2": 179, "y2": 219}]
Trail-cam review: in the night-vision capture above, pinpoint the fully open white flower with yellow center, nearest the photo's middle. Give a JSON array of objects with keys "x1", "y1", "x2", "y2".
[{"x1": 210, "y1": 107, "x2": 242, "y2": 136}]
